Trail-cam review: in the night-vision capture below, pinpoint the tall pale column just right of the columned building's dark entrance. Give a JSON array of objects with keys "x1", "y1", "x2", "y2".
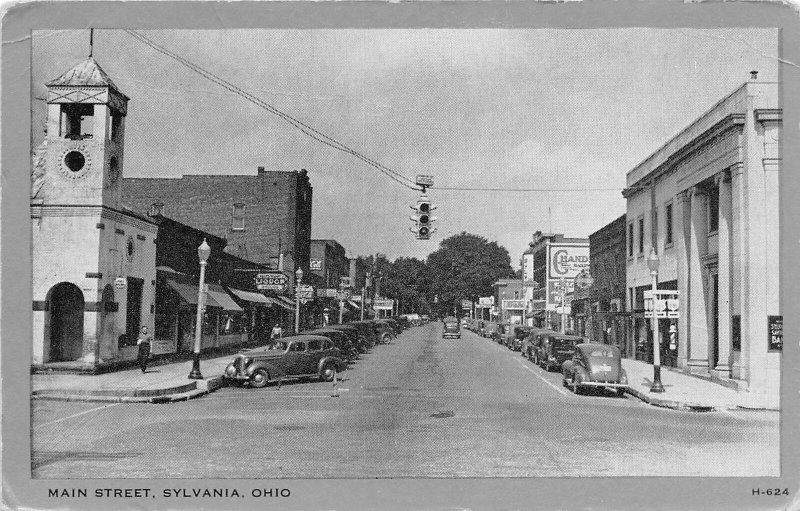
[{"x1": 714, "y1": 171, "x2": 732, "y2": 378}]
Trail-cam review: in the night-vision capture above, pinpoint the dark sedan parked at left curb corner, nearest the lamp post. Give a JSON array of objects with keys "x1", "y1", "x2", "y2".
[{"x1": 224, "y1": 335, "x2": 347, "y2": 389}]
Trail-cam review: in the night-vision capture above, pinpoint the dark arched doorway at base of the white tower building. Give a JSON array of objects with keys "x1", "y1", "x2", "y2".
[{"x1": 48, "y1": 282, "x2": 84, "y2": 362}]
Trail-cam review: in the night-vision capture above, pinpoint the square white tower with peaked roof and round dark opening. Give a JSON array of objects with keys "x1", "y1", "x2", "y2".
[{"x1": 37, "y1": 57, "x2": 128, "y2": 209}]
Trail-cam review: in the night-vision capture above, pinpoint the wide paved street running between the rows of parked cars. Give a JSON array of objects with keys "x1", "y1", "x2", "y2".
[{"x1": 32, "y1": 323, "x2": 779, "y2": 478}]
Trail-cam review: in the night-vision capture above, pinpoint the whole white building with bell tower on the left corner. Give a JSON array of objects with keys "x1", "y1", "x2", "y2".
[{"x1": 31, "y1": 56, "x2": 158, "y2": 367}]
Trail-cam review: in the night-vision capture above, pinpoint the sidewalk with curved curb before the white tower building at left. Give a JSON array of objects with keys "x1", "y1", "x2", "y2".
[{"x1": 31, "y1": 355, "x2": 233, "y2": 403}]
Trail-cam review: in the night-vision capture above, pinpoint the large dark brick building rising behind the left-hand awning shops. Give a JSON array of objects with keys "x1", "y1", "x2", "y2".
[{"x1": 123, "y1": 167, "x2": 312, "y2": 280}]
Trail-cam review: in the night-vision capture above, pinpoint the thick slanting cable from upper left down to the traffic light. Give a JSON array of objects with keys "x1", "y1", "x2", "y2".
[{"x1": 125, "y1": 30, "x2": 419, "y2": 191}]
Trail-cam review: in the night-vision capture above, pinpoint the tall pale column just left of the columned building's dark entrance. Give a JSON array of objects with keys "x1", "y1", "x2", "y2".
[{"x1": 687, "y1": 185, "x2": 709, "y2": 373}]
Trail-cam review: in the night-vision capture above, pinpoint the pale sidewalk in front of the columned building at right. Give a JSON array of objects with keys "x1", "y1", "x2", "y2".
[{"x1": 622, "y1": 358, "x2": 780, "y2": 411}]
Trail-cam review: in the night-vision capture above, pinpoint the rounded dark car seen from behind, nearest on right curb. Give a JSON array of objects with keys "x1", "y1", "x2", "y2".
[{"x1": 561, "y1": 343, "x2": 628, "y2": 394}]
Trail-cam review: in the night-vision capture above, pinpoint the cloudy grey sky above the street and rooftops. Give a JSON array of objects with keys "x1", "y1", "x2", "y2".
[{"x1": 32, "y1": 28, "x2": 779, "y2": 267}]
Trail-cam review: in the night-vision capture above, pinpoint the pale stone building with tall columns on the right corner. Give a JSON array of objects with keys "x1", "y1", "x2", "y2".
[{"x1": 624, "y1": 76, "x2": 783, "y2": 399}]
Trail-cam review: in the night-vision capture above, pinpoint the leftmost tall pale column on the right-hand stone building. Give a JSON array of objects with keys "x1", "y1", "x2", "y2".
[{"x1": 673, "y1": 190, "x2": 691, "y2": 369}]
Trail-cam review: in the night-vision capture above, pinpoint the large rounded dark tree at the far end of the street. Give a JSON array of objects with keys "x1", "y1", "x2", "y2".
[{"x1": 426, "y1": 232, "x2": 514, "y2": 315}]
